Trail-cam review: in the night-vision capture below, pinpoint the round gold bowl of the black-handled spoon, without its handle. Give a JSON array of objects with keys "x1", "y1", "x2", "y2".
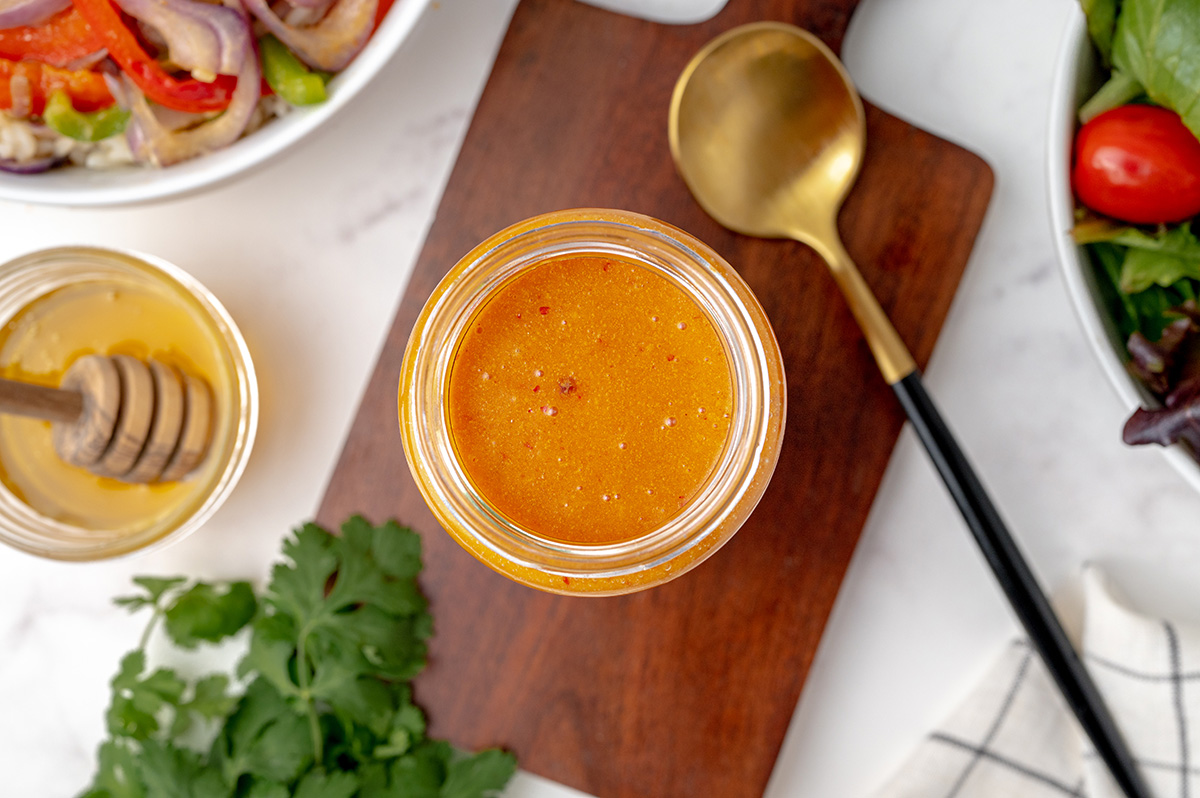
[{"x1": 668, "y1": 22, "x2": 866, "y2": 248}]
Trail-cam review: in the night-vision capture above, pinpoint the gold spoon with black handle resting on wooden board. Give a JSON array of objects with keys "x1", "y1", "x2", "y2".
[{"x1": 668, "y1": 23, "x2": 1150, "y2": 798}]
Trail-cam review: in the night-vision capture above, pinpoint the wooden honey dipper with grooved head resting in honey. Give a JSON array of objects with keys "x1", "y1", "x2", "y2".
[{"x1": 0, "y1": 355, "x2": 212, "y2": 482}]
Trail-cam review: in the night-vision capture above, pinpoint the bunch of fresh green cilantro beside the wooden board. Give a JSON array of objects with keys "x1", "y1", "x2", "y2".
[{"x1": 83, "y1": 517, "x2": 516, "y2": 798}]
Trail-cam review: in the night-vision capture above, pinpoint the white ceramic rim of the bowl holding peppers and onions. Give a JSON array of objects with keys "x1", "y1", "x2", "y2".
[{"x1": 0, "y1": 0, "x2": 431, "y2": 208}]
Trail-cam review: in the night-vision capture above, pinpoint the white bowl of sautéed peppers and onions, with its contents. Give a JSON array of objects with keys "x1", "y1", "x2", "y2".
[{"x1": 0, "y1": 0, "x2": 428, "y2": 205}]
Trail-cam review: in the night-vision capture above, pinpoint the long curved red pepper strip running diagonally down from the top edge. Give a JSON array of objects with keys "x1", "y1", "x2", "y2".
[{"x1": 74, "y1": 0, "x2": 238, "y2": 114}]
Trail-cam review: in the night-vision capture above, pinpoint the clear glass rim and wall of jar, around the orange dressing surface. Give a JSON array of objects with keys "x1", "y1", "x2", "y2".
[{"x1": 398, "y1": 209, "x2": 786, "y2": 595}]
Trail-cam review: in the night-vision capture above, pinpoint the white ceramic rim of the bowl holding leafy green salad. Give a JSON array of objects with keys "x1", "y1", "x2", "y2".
[{"x1": 1046, "y1": 12, "x2": 1200, "y2": 490}]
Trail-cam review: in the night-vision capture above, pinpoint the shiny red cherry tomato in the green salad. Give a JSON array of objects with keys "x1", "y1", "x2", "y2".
[{"x1": 1070, "y1": 106, "x2": 1200, "y2": 224}]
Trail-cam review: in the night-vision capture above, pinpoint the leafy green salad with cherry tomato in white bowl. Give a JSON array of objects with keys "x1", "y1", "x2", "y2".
[{"x1": 1051, "y1": 0, "x2": 1200, "y2": 470}]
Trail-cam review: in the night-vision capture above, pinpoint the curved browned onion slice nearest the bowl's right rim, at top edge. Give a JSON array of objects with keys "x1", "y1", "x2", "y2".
[{"x1": 246, "y1": 0, "x2": 378, "y2": 72}]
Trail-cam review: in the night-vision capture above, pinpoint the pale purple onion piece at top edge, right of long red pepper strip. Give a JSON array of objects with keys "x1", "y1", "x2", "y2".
[{"x1": 114, "y1": 0, "x2": 250, "y2": 80}]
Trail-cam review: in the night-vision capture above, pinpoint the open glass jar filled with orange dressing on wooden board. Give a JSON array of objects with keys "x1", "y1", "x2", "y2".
[{"x1": 400, "y1": 210, "x2": 786, "y2": 595}]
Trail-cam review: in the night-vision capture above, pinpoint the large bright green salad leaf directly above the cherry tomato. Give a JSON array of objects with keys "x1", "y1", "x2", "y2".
[{"x1": 1108, "y1": 0, "x2": 1200, "y2": 136}]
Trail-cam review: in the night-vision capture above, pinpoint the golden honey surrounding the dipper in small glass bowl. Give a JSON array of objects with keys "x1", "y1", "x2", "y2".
[{"x1": 0, "y1": 278, "x2": 233, "y2": 534}]
